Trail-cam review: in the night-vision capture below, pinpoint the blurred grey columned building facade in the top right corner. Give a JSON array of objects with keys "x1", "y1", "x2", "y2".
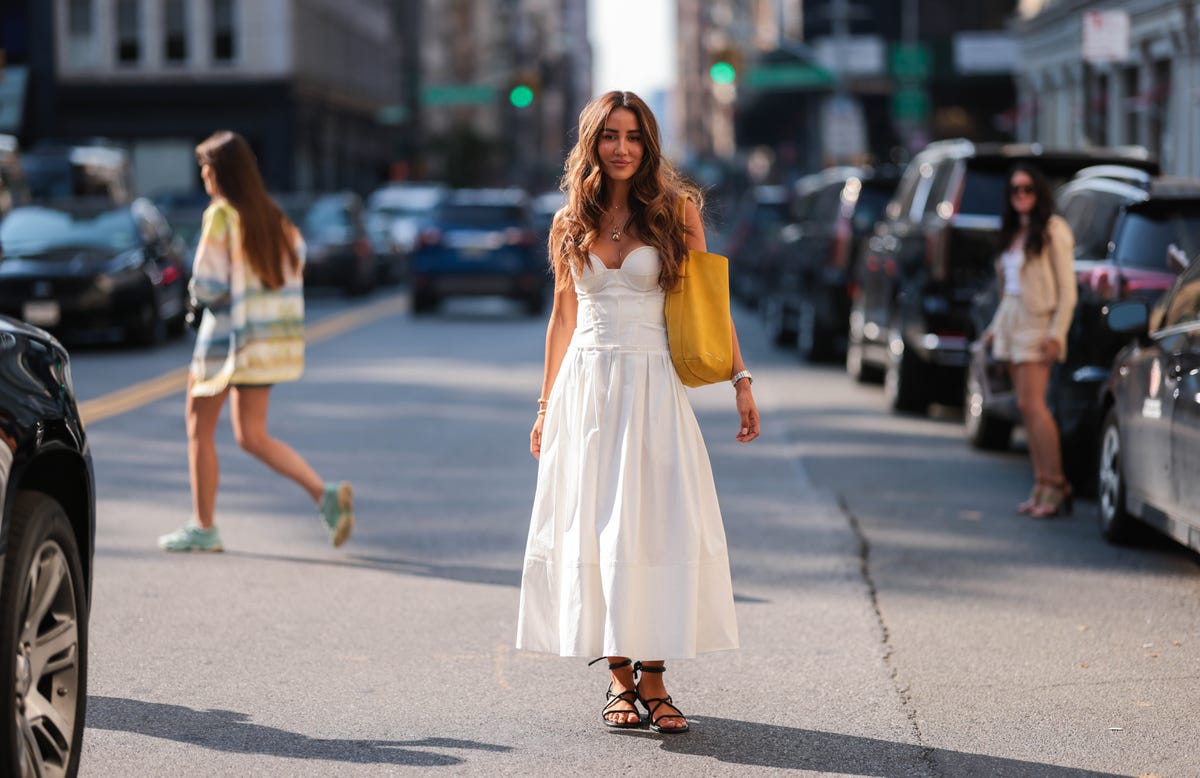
[{"x1": 1015, "y1": 0, "x2": 1200, "y2": 176}]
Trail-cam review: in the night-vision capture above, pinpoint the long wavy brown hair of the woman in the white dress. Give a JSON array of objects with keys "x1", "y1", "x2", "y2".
[{"x1": 550, "y1": 91, "x2": 704, "y2": 291}]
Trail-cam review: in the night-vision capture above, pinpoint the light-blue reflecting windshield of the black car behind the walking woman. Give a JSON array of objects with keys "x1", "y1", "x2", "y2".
[{"x1": 0, "y1": 208, "x2": 140, "y2": 256}]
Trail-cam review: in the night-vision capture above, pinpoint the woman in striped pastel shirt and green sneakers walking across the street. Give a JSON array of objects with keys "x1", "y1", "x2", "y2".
[{"x1": 158, "y1": 131, "x2": 354, "y2": 551}]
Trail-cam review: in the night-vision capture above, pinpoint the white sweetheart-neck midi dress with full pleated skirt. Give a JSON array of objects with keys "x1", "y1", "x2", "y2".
[{"x1": 517, "y1": 246, "x2": 738, "y2": 659}]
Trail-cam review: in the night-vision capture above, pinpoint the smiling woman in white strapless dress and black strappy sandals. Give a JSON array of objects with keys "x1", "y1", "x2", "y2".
[{"x1": 517, "y1": 91, "x2": 758, "y2": 734}]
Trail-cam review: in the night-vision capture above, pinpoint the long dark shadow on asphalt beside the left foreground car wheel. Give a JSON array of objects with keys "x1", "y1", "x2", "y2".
[{"x1": 88, "y1": 696, "x2": 512, "y2": 767}]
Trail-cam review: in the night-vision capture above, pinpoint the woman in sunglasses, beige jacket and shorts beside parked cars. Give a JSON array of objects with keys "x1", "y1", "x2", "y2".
[{"x1": 984, "y1": 162, "x2": 1076, "y2": 519}]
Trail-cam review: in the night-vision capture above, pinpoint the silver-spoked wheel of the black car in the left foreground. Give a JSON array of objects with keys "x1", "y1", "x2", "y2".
[{"x1": 0, "y1": 491, "x2": 88, "y2": 776}]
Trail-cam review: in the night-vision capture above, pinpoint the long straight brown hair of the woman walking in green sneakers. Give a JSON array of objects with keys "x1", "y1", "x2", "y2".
[{"x1": 196, "y1": 130, "x2": 300, "y2": 289}]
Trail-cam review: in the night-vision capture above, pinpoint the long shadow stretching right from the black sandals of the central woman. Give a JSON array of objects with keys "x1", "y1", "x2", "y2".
[{"x1": 613, "y1": 716, "x2": 1118, "y2": 778}]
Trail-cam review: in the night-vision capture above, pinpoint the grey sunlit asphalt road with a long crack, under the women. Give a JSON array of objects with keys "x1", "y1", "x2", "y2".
[{"x1": 74, "y1": 286, "x2": 1200, "y2": 778}]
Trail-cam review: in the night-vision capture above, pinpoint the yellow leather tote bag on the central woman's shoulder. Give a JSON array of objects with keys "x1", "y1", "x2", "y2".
[{"x1": 665, "y1": 197, "x2": 733, "y2": 387}]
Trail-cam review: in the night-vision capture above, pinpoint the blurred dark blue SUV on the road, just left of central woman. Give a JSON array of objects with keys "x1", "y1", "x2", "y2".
[{"x1": 412, "y1": 188, "x2": 551, "y2": 316}]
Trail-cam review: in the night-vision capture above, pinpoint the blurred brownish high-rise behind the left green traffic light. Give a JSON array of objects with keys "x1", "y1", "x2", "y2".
[{"x1": 419, "y1": 0, "x2": 592, "y2": 190}]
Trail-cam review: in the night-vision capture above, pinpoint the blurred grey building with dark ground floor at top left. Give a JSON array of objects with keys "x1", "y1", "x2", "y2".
[{"x1": 36, "y1": 0, "x2": 401, "y2": 193}]
